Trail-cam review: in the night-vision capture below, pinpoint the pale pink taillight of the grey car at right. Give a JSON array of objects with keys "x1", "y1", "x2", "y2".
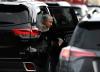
[{"x1": 60, "y1": 47, "x2": 96, "y2": 59}]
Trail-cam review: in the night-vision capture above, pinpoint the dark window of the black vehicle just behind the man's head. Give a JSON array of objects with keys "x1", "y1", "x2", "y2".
[{"x1": 49, "y1": 6, "x2": 74, "y2": 27}]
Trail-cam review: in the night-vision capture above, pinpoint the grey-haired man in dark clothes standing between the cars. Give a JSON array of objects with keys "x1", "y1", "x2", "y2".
[{"x1": 38, "y1": 14, "x2": 62, "y2": 72}]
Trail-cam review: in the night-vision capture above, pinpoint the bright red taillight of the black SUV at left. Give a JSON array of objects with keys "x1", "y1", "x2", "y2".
[{"x1": 12, "y1": 28, "x2": 40, "y2": 38}]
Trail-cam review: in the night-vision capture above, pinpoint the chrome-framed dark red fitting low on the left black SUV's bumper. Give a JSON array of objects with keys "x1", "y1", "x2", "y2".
[{"x1": 23, "y1": 62, "x2": 36, "y2": 72}]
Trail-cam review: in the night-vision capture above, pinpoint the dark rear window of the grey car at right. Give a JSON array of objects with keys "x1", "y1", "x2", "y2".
[{"x1": 70, "y1": 22, "x2": 100, "y2": 50}]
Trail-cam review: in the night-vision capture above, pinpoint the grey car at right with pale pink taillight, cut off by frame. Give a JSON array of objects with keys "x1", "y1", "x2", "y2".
[{"x1": 58, "y1": 13, "x2": 100, "y2": 72}]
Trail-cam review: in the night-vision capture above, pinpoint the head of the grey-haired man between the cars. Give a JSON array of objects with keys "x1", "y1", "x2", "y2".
[{"x1": 42, "y1": 14, "x2": 53, "y2": 28}]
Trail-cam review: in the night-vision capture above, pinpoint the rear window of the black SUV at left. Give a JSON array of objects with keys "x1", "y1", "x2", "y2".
[{"x1": 0, "y1": 5, "x2": 29, "y2": 25}]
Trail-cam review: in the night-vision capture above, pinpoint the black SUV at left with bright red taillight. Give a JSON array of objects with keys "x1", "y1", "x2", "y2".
[{"x1": 0, "y1": 2, "x2": 49, "y2": 72}]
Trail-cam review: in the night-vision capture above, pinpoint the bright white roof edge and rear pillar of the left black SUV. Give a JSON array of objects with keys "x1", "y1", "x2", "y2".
[{"x1": 0, "y1": 1, "x2": 47, "y2": 22}]
